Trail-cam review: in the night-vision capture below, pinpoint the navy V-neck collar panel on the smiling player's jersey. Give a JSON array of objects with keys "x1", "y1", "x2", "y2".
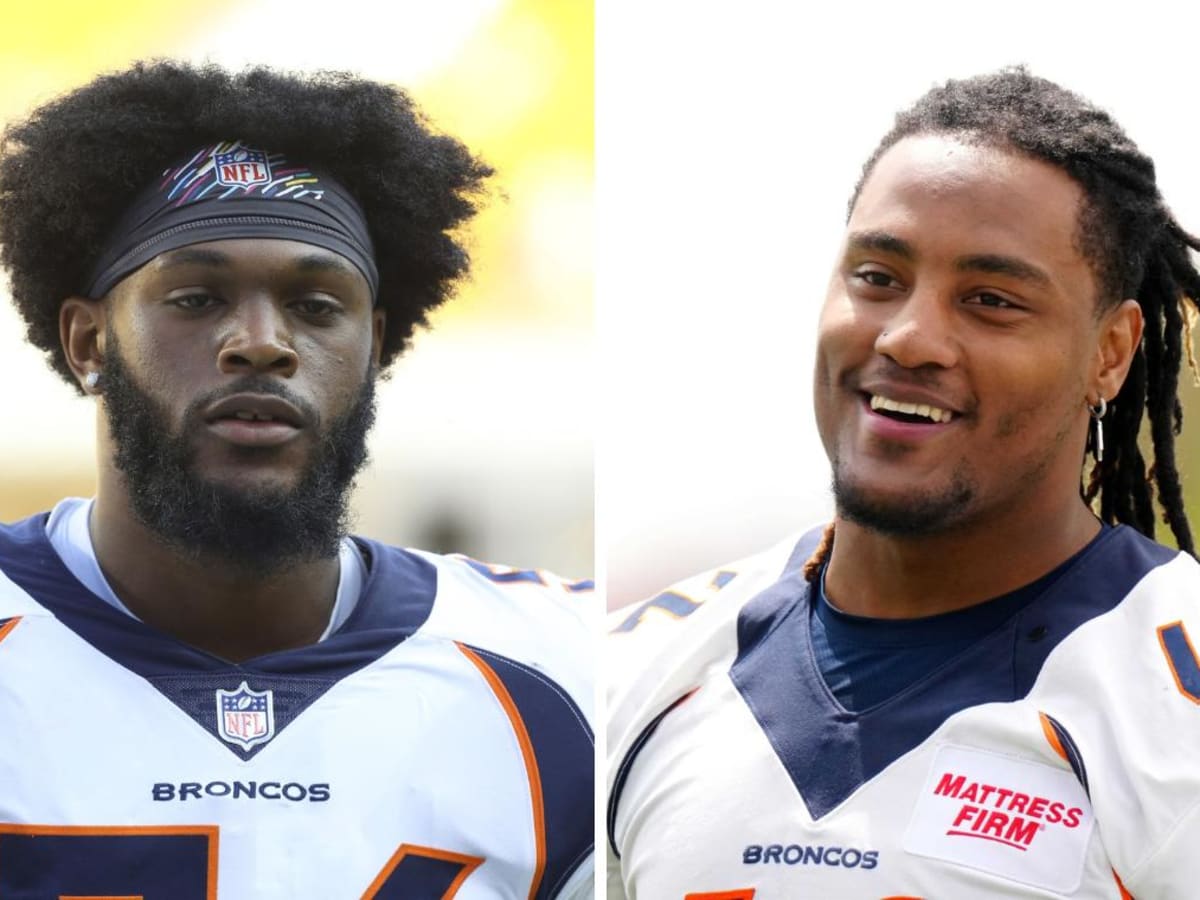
[{"x1": 730, "y1": 526, "x2": 1176, "y2": 818}]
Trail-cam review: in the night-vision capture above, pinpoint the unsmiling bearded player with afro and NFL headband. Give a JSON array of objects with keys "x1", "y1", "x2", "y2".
[{"x1": 0, "y1": 62, "x2": 593, "y2": 900}]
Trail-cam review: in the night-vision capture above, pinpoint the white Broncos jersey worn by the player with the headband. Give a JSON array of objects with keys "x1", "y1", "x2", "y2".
[{"x1": 0, "y1": 516, "x2": 593, "y2": 900}]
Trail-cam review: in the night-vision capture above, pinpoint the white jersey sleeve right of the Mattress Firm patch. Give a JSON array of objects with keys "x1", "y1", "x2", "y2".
[{"x1": 1046, "y1": 553, "x2": 1200, "y2": 900}]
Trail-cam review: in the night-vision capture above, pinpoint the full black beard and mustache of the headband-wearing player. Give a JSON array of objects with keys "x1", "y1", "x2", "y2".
[{"x1": 102, "y1": 331, "x2": 376, "y2": 575}]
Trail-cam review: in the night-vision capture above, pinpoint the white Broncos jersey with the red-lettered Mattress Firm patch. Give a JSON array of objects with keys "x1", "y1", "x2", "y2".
[{"x1": 607, "y1": 527, "x2": 1200, "y2": 900}]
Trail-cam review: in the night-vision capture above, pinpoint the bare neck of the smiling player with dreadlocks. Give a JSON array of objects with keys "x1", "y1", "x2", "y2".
[{"x1": 826, "y1": 497, "x2": 1100, "y2": 619}]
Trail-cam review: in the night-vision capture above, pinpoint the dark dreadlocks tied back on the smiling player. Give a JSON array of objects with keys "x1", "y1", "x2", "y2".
[{"x1": 805, "y1": 67, "x2": 1200, "y2": 577}]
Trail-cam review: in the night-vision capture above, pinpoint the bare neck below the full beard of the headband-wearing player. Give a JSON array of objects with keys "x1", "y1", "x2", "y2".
[{"x1": 89, "y1": 475, "x2": 340, "y2": 661}]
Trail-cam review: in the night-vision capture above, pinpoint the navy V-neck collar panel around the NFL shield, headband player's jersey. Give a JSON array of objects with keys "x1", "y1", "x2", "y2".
[{"x1": 0, "y1": 515, "x2": 437, "y2": 760}]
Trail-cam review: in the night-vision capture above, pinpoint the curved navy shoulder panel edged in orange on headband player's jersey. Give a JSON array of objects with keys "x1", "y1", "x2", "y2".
[{"x1": 456, "y1": 647, "x2": 595, "y2": 900}]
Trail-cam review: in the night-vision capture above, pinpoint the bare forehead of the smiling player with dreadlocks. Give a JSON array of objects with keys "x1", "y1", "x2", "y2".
[{"x1": 848, "y1": 134, "x2": 1090, "y2": 285}]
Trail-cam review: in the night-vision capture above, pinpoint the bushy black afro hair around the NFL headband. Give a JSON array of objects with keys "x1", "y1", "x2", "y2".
[{"x1": 0, "y1": 61, "x2": 492, "y2": 388}]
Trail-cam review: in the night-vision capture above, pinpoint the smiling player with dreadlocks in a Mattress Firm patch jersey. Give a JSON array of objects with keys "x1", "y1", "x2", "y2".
[{"x1": 607, "y1": 68, "x2": 1200, "y2": 900}]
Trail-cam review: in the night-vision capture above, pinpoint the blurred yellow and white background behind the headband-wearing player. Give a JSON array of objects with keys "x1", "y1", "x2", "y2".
[{"x1": 0, "y1": 0, "x2": 594, "y2": 576}]
